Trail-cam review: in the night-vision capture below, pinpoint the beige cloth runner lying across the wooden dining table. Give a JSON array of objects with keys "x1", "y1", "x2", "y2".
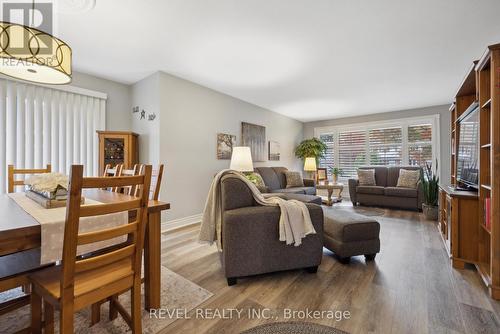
[{"x1": 9, "y1": 193, "x2": 128, "y2": 264}]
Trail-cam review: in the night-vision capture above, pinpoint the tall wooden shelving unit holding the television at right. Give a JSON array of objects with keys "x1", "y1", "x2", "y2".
[{"x1": 440, "y1": 44, "x2": 500, "y2": 299}]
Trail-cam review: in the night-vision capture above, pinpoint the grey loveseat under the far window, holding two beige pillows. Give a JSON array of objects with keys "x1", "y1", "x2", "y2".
[{"x1": 349, "y1": 166, "x2": 423, "y2": 210}]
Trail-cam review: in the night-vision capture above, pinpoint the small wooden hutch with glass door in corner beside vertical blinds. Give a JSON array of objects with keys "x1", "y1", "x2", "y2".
[{"x1": 97, "y1": 131, "x2": 139, "y2": 173}]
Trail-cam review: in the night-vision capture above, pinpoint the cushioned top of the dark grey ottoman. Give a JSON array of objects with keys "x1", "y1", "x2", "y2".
[{"x1": 323, "y1": 209, "x2": 380, "y2": 242}]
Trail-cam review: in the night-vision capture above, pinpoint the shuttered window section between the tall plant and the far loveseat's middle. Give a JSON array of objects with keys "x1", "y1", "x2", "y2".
[{"x1": 337, "y1": 130, "x2": 366, "y2": 178}]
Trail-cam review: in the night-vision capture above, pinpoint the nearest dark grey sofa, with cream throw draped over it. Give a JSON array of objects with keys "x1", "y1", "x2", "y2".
[{"x1": 221, "y1": 178, "x2": 323, "y2": 285}]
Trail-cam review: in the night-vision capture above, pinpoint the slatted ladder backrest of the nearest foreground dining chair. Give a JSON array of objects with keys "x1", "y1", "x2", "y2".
[{"x1": 60, "y1": 165, "x2": 151, "y2": 303}]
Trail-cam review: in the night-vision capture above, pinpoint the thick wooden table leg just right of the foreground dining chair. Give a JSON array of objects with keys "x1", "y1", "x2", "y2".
[{"x1": 144, "y1": 212, "x2": 161, "y2": 310}]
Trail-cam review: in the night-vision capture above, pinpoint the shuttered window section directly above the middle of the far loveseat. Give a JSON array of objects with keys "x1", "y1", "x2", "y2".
[{"x1": 368, "y1": 127, "x2": 403, "y2": 166}]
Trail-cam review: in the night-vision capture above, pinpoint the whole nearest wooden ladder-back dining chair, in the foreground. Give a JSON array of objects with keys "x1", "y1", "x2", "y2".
[{"x1": 30, "y1": 165, "x2": 151, "y2": 334}]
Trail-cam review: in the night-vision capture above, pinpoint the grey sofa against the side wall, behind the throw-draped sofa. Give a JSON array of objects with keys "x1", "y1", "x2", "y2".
[{"x1": 255, "y1": 167, "x2": 316, "y2": 195}]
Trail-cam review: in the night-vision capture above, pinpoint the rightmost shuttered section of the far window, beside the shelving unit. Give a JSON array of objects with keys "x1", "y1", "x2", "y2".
[{"x1": 408, "y1": 124, "x2": 432, "y2": 166}]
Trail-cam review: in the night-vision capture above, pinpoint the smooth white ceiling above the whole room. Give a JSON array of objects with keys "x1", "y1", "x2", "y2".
[{"x1": 57, "y1": 0, "x2": 500, "y2": 121}]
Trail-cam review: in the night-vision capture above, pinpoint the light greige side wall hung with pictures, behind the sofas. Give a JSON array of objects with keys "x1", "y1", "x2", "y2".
[{"x1": 132, "y1": 72, "x2": 303, "y2": 220}]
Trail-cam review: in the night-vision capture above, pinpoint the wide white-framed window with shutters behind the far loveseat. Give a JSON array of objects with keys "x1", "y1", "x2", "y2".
[{"x1": 314, "y1": 115, "x2": 440, "y2": 182}]
